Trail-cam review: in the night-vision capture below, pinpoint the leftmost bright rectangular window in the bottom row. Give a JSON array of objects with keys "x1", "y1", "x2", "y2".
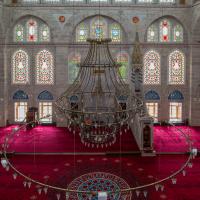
[{"x1": 15, "y1": 102, "x2": 28, "y2": 122}]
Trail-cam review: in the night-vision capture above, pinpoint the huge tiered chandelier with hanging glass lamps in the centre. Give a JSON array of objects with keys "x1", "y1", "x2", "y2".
[{"x1": 55, "y1": 39, "x2": 143, "y2": 147}]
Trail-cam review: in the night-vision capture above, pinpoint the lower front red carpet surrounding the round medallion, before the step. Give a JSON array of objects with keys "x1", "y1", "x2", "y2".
[{"x1": 0, "y1": 155, "x2": 200, "y2": 200}]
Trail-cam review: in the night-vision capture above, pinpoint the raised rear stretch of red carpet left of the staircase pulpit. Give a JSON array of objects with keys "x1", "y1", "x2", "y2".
[{"x1": 0, "y1": 126, "x2": 138, "y2": 152}]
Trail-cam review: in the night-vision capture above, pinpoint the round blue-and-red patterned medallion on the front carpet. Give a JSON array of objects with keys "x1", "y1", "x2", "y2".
[{"x1": 66, "y1": 172, "x2": 131, "y2": 200}]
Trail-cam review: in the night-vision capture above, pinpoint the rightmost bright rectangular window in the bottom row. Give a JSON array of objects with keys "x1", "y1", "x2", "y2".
[{"x1": 169, "y1": 102, "x2": 182, "y2": 122}]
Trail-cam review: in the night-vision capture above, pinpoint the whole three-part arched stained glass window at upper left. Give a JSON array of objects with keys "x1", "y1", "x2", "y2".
[{"x1": 14, "y1": 18, "x2": 50, "y2": 42}]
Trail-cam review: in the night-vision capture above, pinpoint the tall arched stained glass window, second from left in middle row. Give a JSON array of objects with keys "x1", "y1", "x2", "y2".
[{"x1": 36, "y1": 49, "x2": 54, "y2": 84}]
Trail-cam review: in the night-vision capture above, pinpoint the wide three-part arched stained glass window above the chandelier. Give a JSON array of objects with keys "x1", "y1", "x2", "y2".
[{"x1": 76, "y1": 16, "x2": 122, "y2": 42}]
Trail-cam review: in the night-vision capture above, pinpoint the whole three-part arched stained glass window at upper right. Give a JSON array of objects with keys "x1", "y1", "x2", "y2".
[{"x1": 147, "y1": 18, "x2": 184, "y2": 43}]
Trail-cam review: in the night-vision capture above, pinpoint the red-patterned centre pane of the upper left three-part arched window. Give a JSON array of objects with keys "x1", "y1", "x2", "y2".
[{"x1": 27, "y1": 19, "x2": 38, "y2": 42}]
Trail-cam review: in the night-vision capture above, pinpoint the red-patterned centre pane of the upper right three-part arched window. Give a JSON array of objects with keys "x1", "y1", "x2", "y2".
[{"x1": 160, "y1": 19, "x2": 171, "y2": 42}]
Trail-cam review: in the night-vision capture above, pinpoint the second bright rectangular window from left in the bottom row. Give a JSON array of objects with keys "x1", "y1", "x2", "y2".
[{"x1": 39, "y1": 102, "x2": 52, "y2": 123}]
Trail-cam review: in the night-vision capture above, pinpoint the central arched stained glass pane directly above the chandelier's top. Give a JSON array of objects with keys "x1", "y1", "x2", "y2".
[{"x1": 91, "y1": 17, "x2": 107, "y2": 39}]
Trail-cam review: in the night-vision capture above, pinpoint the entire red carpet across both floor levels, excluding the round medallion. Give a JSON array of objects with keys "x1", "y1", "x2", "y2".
[{"x1": 0, "y1": 126, "x2": 200, "y2": 200}]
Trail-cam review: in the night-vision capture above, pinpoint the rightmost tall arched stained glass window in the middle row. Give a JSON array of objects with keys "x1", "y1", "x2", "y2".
[{"x1": 169, "y1": 50, "x2": 185, "y2": 85}]
